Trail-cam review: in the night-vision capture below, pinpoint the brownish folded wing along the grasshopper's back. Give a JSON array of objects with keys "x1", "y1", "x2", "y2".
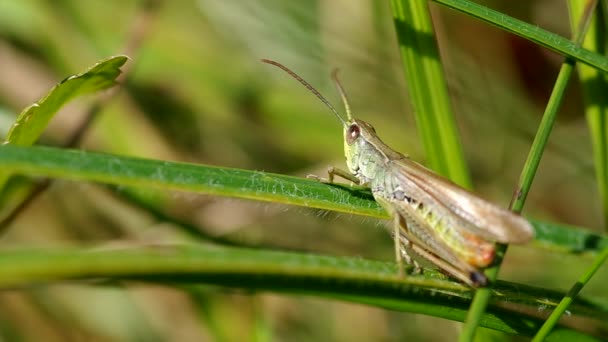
[{"x1": 392, "y1": 159, "x2": 534, "y2": 243}]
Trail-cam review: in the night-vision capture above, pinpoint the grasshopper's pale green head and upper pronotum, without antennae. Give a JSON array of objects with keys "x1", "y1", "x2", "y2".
[{"x1": 344, "y1": 119, "x2": 404, "y2": 184}]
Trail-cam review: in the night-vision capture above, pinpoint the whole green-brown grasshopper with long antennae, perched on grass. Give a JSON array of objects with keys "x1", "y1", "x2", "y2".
[{"x1": 262, "y1": 59, "x2": 534, "y2": 287}]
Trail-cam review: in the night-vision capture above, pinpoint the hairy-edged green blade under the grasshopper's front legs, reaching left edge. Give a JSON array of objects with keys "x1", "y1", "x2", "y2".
[{"x1": 0, "y1": 145, "x2": 608, "y2": 255}]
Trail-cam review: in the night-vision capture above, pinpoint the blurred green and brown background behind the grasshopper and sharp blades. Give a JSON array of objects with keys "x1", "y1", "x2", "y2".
[{"x1": 0, "y1": 0, "x2": 608, "y2": 341}]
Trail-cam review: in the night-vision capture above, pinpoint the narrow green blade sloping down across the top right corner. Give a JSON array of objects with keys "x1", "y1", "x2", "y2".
[{"x1": 433, "y1": 0, "x2": 608, "y2": 72}]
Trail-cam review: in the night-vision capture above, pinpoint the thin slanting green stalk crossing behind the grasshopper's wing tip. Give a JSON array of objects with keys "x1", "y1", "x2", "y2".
[{"x1": 459, "y1": 0, "x2": 597, "y2": 341}]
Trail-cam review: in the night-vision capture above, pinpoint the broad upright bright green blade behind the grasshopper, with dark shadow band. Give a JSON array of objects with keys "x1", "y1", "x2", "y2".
[{"x1": 391, "y1": 0, "x2": 471, "y2": 188}]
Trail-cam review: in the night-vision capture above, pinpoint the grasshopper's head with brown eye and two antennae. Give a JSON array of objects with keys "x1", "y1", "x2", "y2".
[{"x1": 262, "y1": 59, "x2": 376, "y2": 174}]
